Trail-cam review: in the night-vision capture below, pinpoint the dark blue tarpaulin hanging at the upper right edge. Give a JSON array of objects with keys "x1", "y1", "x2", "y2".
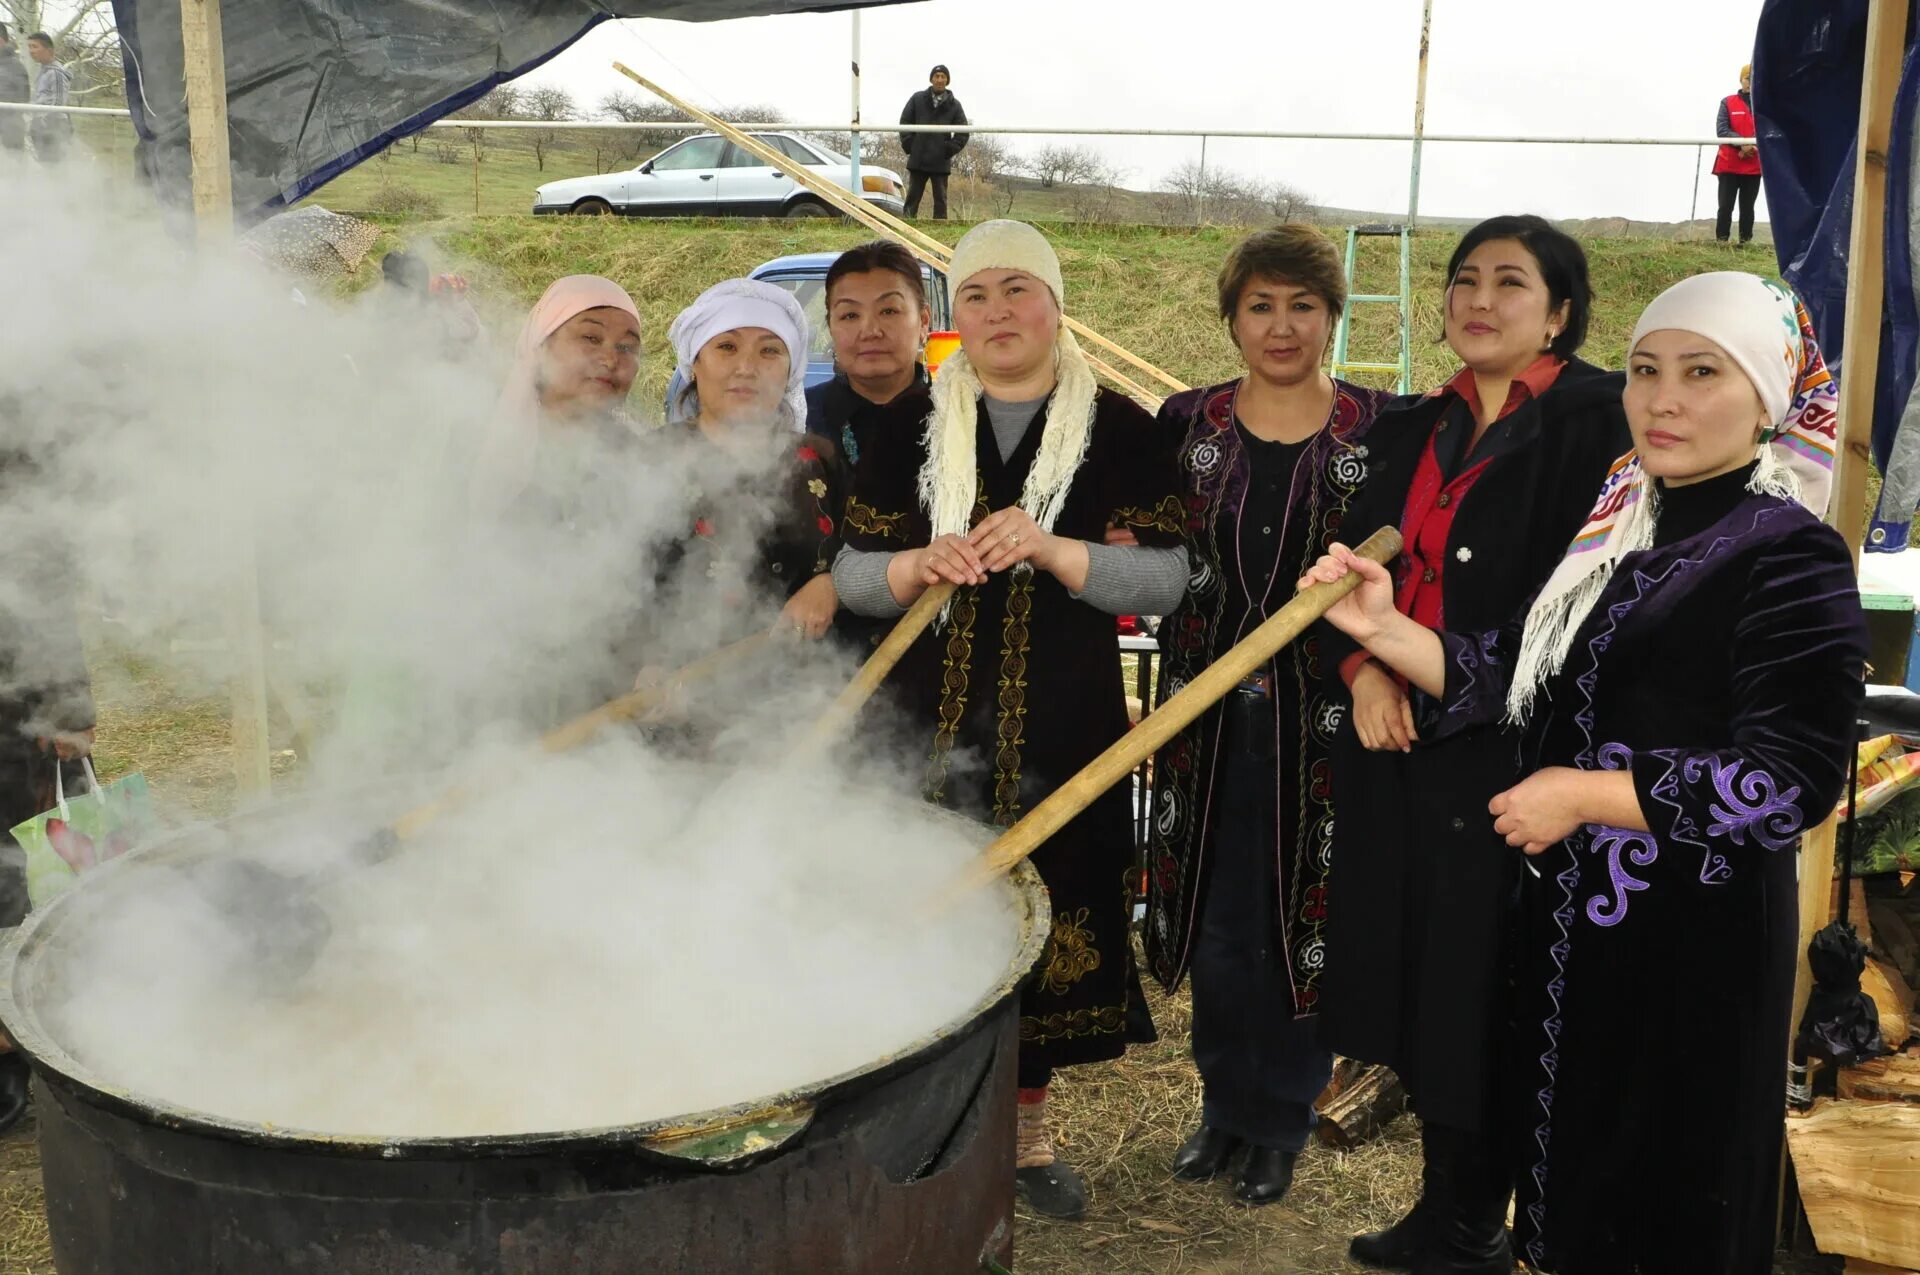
[{"x1": 1753, "y1": 0, "x2": 1920, "y2": 553}]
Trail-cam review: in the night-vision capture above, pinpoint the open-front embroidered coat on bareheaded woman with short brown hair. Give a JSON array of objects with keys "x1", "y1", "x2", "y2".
[{"x1": 1146, "y1": 382, "x2": 1392, "y2": 1016}]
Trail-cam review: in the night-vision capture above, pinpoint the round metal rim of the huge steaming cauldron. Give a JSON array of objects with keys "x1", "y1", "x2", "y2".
[{"x1": 0, "y1": 803, "x2": 1052, "y2": 1164}]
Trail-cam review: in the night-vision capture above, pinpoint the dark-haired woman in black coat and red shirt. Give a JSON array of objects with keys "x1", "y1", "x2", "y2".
[{"x1": 1321, "y1": 215, "x2": 1632, "y2": 1275}]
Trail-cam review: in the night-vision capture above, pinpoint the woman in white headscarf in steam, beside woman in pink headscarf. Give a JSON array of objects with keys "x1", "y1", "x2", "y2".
[{"x1": 662, "y1": 278, "x2": 847, "y2": 639}]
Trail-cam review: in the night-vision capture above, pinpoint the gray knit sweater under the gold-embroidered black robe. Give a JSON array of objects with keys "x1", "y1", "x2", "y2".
[{"x1": 833, "y1": 394, "x2": 1187, "y2": 618}]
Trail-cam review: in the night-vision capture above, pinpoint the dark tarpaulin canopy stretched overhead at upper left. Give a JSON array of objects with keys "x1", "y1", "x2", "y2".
[{"x1": 113, "y1": 0, "x2": 906, "y2": 221}]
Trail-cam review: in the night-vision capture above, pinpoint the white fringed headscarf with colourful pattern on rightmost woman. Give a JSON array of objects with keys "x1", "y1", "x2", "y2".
[{"x1": 1507, "y1": 271, "x2": 1839, "y2": 724}]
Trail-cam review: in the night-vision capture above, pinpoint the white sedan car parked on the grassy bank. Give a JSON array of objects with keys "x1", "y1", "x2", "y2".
[{"x1": 534, "y1": 132, "x2": 906, "y2": 217}]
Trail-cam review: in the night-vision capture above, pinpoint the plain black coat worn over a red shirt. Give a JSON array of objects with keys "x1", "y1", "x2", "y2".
[{"x1": 1319, "y1": 359, "x2": 1632, "y2": 1131}]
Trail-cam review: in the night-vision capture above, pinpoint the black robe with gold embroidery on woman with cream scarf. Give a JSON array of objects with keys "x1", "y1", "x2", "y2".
[{"x1": 847, "y1": 390, "x2": 1181, "y2": 1075}]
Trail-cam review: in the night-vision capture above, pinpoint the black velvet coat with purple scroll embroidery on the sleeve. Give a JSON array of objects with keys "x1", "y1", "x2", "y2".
[{"x1": 1438, "y1": 472, "x2": 1866, "y2": 1275}]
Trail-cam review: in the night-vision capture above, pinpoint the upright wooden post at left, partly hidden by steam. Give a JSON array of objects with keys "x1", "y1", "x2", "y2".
[{"x1": 180, "y1": 0, "x2": 273, "y2": 801}]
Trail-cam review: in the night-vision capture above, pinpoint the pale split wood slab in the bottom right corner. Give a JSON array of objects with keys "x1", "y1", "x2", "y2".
[{"x1": 1788, "y1": 1098, "x2": 1920, "y2": 1267}]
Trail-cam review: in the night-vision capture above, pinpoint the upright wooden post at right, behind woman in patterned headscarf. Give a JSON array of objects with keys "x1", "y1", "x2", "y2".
[{"x1": 1788, "y1": 0, "x2": 1908, "y2": 1056}]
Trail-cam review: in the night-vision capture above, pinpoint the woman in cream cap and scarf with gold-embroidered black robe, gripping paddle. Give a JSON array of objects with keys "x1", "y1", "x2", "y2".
[{"x1": 833, "y1": 221, "x2": 1187, "y2": 1217}]
